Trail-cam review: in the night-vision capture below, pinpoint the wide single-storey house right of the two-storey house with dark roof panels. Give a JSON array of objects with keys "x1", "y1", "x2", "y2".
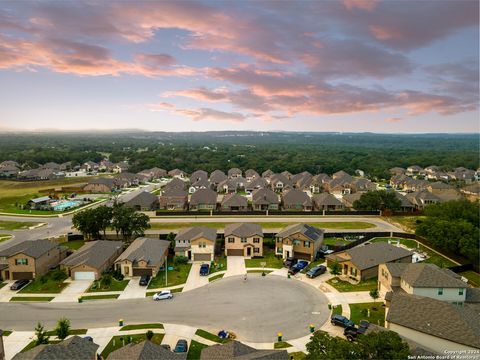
[{"x1": 326, "y1": 242, "x2": 413, "y2": 281}]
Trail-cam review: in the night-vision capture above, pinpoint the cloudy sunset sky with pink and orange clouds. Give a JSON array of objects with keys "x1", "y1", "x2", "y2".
[{"x1": 0, "y1": 0, "x2": 480, "y2": 133}]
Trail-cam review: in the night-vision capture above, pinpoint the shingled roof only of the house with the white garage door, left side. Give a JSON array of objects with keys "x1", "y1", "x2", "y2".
[{"x1": 60, "y1": 240, "x2": 123, "y2": 268}]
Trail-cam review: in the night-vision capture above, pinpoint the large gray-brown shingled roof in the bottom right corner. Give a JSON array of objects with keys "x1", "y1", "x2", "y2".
[{"x1": 386, "y1": 293, "x2": 480, "y2": 348}]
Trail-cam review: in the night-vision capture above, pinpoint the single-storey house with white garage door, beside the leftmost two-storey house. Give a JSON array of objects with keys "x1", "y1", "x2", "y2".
[{"x1": 60, "y1": 240, "x2": 123, "y2": 280}]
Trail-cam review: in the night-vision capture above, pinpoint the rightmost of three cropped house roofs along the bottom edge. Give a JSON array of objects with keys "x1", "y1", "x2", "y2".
[{"x1": 200, "y1": 340, "x2": 289, "y2": 360}]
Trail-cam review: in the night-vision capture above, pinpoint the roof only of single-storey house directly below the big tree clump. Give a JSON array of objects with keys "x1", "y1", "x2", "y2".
[{"x1": 115, "y1": 237, "x2": 170, "y2": 267}]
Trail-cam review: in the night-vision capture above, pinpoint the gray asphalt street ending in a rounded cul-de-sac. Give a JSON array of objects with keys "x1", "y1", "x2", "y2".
[{"x1": 0, "y1": 274, "x2": 329, "y2": 342}]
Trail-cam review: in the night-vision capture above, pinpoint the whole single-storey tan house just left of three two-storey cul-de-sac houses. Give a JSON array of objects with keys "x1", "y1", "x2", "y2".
[{"x1": 115, "y1": 237, "x2": 170, "y2": 277}]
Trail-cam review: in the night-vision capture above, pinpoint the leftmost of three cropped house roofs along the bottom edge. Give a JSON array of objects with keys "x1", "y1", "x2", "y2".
[{"x1": 13, "y1": 336, "x2": 99, "y2": 360}]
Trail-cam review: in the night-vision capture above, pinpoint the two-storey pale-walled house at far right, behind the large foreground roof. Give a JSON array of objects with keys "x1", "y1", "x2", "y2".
[{"x1": 378, "y1": 263, "x2": 468, "y2": 305}]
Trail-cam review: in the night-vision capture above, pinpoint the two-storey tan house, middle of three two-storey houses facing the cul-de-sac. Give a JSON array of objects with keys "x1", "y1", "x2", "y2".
[{"x1": 224, "y1": 223, "x2": 263, "y2": 257}]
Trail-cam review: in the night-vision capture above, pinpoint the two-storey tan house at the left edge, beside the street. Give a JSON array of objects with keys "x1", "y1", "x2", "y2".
[{"x1": 0, "y1": 240, "x2": 66, "y2": 280}]
